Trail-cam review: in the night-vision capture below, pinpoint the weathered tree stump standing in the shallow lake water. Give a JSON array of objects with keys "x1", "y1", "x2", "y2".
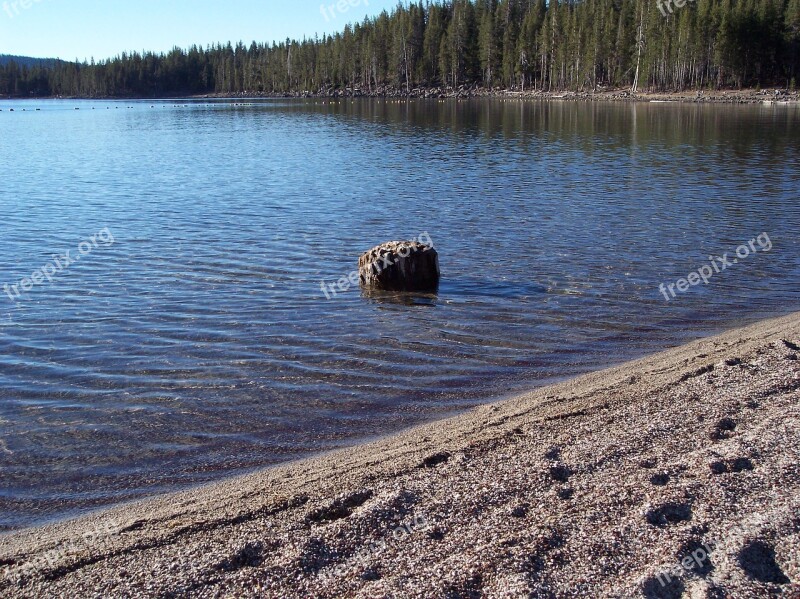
[{"x1": 358, "y1": 241, "x2": 439, "y2": 291}]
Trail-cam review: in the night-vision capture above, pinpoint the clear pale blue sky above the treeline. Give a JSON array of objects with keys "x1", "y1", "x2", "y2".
[{"x1": 0, "y1": 0, "x2": 398, "y2": 60}]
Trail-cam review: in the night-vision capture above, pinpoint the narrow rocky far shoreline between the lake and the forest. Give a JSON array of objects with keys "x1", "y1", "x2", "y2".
[{"x1": 0, "y1": 86, "x2": 800, "y2": 104}]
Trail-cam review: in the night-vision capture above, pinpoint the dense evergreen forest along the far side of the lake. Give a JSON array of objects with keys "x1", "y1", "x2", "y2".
[{"x1": 0, "y1": 0, "x2": 800, "y2": 98}]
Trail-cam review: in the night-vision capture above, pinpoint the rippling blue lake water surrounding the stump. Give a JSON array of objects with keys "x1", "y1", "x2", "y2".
[{"x1": 0, "y1": 100, "x2": 800, "y2": 529}]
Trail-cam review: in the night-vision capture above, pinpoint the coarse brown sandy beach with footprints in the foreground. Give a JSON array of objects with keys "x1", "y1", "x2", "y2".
[{"x1": 0, "y1": 313, "x2": 800, "y2": 598}]
